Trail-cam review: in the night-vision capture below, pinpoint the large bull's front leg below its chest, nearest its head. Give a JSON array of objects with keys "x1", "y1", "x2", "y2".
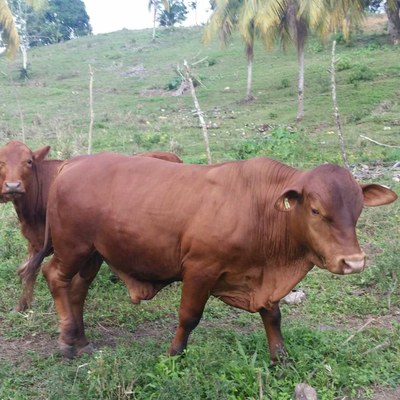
[{"x1": 259, "y1": 303, "x2": 285, "y2": 364}]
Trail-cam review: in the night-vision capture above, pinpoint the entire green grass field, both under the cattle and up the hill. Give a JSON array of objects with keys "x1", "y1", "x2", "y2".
[{"x1": 0, "y1": 17, "x2": 400, "y2": 400}]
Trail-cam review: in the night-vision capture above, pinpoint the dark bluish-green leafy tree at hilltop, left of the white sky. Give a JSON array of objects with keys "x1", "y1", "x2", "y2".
[{"x1": 27, "y1": 0, "x2": 92, "y2": 46}]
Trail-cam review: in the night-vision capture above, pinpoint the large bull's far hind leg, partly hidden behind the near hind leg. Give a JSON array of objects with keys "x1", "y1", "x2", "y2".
[{"x1": 70, "y1": 253, "x2": 103, "y2": 355}]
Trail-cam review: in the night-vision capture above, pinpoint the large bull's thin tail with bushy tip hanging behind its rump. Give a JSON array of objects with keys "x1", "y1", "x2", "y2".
[{"x1": 17, "y1": 213, "x2": 53, "y2": 290}]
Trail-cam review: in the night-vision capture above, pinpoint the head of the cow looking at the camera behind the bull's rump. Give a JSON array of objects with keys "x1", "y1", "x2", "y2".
[{"x1": 0, "y1": 141, "x2": 50, "y2": 202}]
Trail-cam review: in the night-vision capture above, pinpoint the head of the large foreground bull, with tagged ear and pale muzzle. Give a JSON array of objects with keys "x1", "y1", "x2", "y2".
[{"x1": 275, "y1": 164, "x2": 397, "y2": 274}]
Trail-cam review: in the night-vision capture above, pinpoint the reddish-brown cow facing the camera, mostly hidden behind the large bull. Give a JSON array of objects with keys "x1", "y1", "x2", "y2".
[{"x1": 0, "y1": 141, "x2": 182, "y2": 311}]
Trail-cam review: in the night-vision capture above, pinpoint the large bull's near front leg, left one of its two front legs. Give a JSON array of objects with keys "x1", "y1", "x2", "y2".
[{"x1": 169, "y1": 266, "x2": 218, "y2": 356}]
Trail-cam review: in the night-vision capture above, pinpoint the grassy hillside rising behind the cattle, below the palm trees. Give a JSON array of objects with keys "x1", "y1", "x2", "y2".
[{"x1": 0, "y1": 14, "x2": 400, "y2": 163}]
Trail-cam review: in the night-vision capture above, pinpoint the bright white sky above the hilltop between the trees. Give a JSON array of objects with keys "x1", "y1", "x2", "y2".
[{"x1": 83, "y1": 0, "x2": 210, "y2": 35}]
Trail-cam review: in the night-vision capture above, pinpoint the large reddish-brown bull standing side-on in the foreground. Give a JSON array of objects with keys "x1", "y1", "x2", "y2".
[{"x1": 22, "y1": 153, "x2": 397, "y2": 362}]
